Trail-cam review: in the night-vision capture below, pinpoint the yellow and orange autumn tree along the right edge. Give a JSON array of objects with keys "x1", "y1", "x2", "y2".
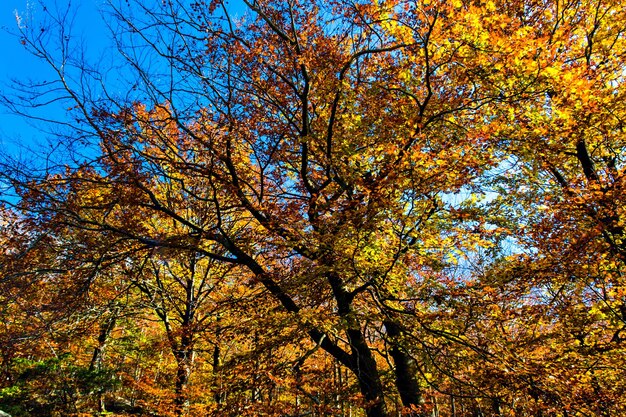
[{"x1": 472, "y1": 2, "x2": 625, "y2": 415}]
